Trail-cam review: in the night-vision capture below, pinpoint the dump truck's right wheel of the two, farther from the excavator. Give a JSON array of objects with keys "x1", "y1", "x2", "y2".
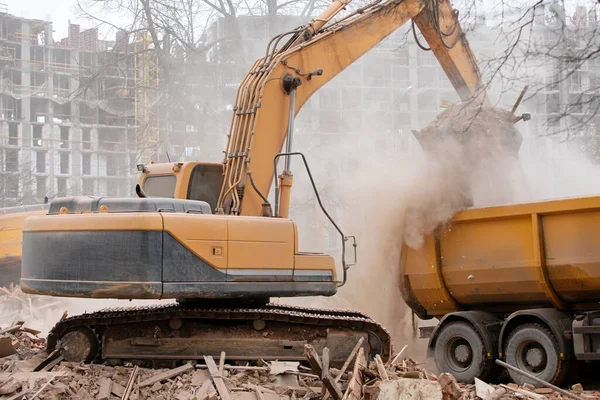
[{"x1": 504, "y1": 324, "x2": 569, "y2": 387}]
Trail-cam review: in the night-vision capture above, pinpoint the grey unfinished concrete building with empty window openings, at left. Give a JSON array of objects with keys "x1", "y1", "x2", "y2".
[{"x1": 0, "y1": 14, "x2": 136, "y2": 206}]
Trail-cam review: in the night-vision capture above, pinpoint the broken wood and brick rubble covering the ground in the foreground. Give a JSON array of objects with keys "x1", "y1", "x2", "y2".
[{"x1": 0, "y1": 328, "x2": 600, "y2": 400}]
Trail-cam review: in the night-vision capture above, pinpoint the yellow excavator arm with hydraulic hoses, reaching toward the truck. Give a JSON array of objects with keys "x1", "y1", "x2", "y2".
[{"x1": 217, "y1": 0, "x2": 483, "y2": 216}]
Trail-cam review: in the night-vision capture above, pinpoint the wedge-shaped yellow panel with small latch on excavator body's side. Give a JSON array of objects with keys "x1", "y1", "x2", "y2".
[{"x1": 162, "y1": 213, "x2": 228, "y2": 269}]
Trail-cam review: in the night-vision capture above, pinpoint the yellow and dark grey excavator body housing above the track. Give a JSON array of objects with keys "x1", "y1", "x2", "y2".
[{"x1": 21, "y1": 197, "x2": 337, "y2": 299}]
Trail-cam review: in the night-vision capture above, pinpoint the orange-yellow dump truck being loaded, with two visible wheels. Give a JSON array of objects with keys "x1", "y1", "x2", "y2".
[{"x1": 400, "y1": 196, "x2": 600, "y2": 385}]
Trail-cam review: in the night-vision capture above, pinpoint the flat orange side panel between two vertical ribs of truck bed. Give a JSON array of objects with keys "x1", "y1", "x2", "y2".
[{"x1": 440, "y1": 215, "x2": 546, "y2": 304}]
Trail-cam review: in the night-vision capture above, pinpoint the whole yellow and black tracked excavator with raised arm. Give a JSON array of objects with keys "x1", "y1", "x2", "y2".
[{"x1": 21, "y1": 0, "x2": 500, "y2": 366}]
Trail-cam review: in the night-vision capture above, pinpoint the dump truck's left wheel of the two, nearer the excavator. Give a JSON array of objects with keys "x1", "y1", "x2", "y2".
[{"x1": 434, "y1": 322, "x2": 494, "y2": 383}]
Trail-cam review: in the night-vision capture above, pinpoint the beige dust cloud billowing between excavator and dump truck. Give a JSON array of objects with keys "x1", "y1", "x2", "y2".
[{"x1": 282, "y1": 101, "x2": 600, "y2": 362}]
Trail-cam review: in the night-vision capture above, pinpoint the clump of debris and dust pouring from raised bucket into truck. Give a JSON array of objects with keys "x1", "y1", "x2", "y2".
[{"x1": 403, "y1": 102, "x2": 522, "y2": 248}]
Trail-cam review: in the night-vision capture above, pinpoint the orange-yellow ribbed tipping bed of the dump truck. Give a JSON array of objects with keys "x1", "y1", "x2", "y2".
[{"x1": 400, "y1": 196, "x2": 600, "y2": 319}]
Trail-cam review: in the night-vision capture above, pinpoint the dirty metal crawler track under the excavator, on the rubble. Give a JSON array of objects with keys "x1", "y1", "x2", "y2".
[{"x1": 48, "y1": 304, "x2": 392, "y2": 367}]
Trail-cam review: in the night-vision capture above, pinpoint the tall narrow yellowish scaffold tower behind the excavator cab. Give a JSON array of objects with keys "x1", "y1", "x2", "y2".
[{"x1": 133, "y1": 33, "x2": 160, "y2": 162}]
